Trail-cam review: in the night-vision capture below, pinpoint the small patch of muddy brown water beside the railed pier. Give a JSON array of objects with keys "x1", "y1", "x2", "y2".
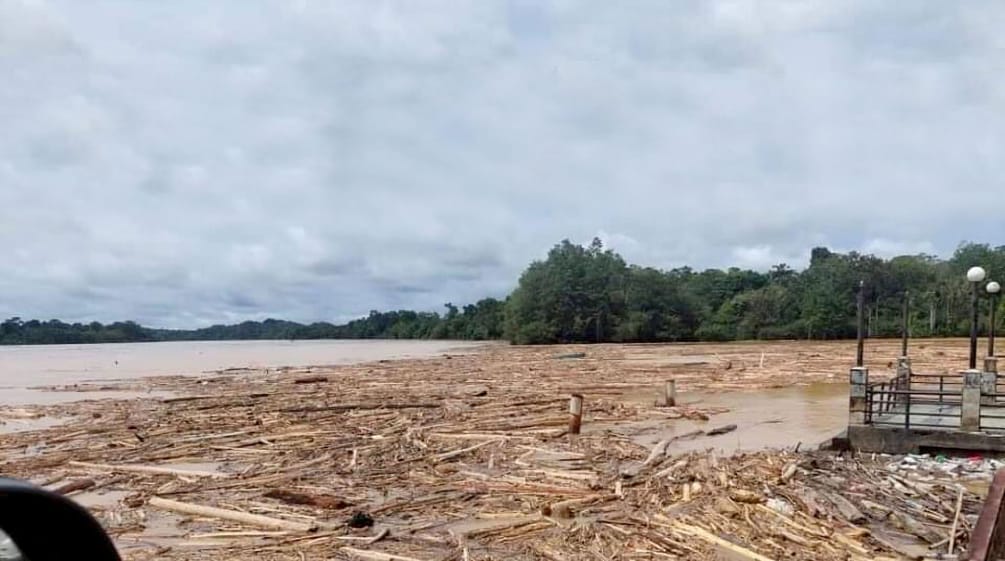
[{"x1": 613, "y1": 383, "x2": 848, "y2": 454}]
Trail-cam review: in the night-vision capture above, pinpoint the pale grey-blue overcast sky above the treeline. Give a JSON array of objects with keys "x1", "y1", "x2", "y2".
[{"x1": 0, "y1": 0, "x2": 1005, "y2": 327}]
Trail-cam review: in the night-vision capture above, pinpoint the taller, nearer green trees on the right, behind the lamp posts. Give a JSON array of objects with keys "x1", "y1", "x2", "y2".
[{"x1": 506, "y1": 241, "x2": 1005, "y2": 344}]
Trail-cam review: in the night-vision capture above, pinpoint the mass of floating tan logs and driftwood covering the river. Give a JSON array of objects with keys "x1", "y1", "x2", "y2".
[{"x1": 0, "y1": 340, "x2": 981, "y2": 561}]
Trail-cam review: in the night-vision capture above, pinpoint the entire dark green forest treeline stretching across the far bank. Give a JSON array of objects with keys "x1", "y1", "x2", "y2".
[{"x1": 0, "y1": 240, "x2": 1005, "y2": 345}]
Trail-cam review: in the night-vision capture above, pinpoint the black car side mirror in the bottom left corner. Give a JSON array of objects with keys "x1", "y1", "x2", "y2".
[{"x1": 0, "y1": 479, "x2": 121, "y2": 561}]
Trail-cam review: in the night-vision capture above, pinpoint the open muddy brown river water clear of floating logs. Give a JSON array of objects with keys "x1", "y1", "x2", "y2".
[{"x1": 0, "y1": 341, "x2": 848, "y2": 453}]
